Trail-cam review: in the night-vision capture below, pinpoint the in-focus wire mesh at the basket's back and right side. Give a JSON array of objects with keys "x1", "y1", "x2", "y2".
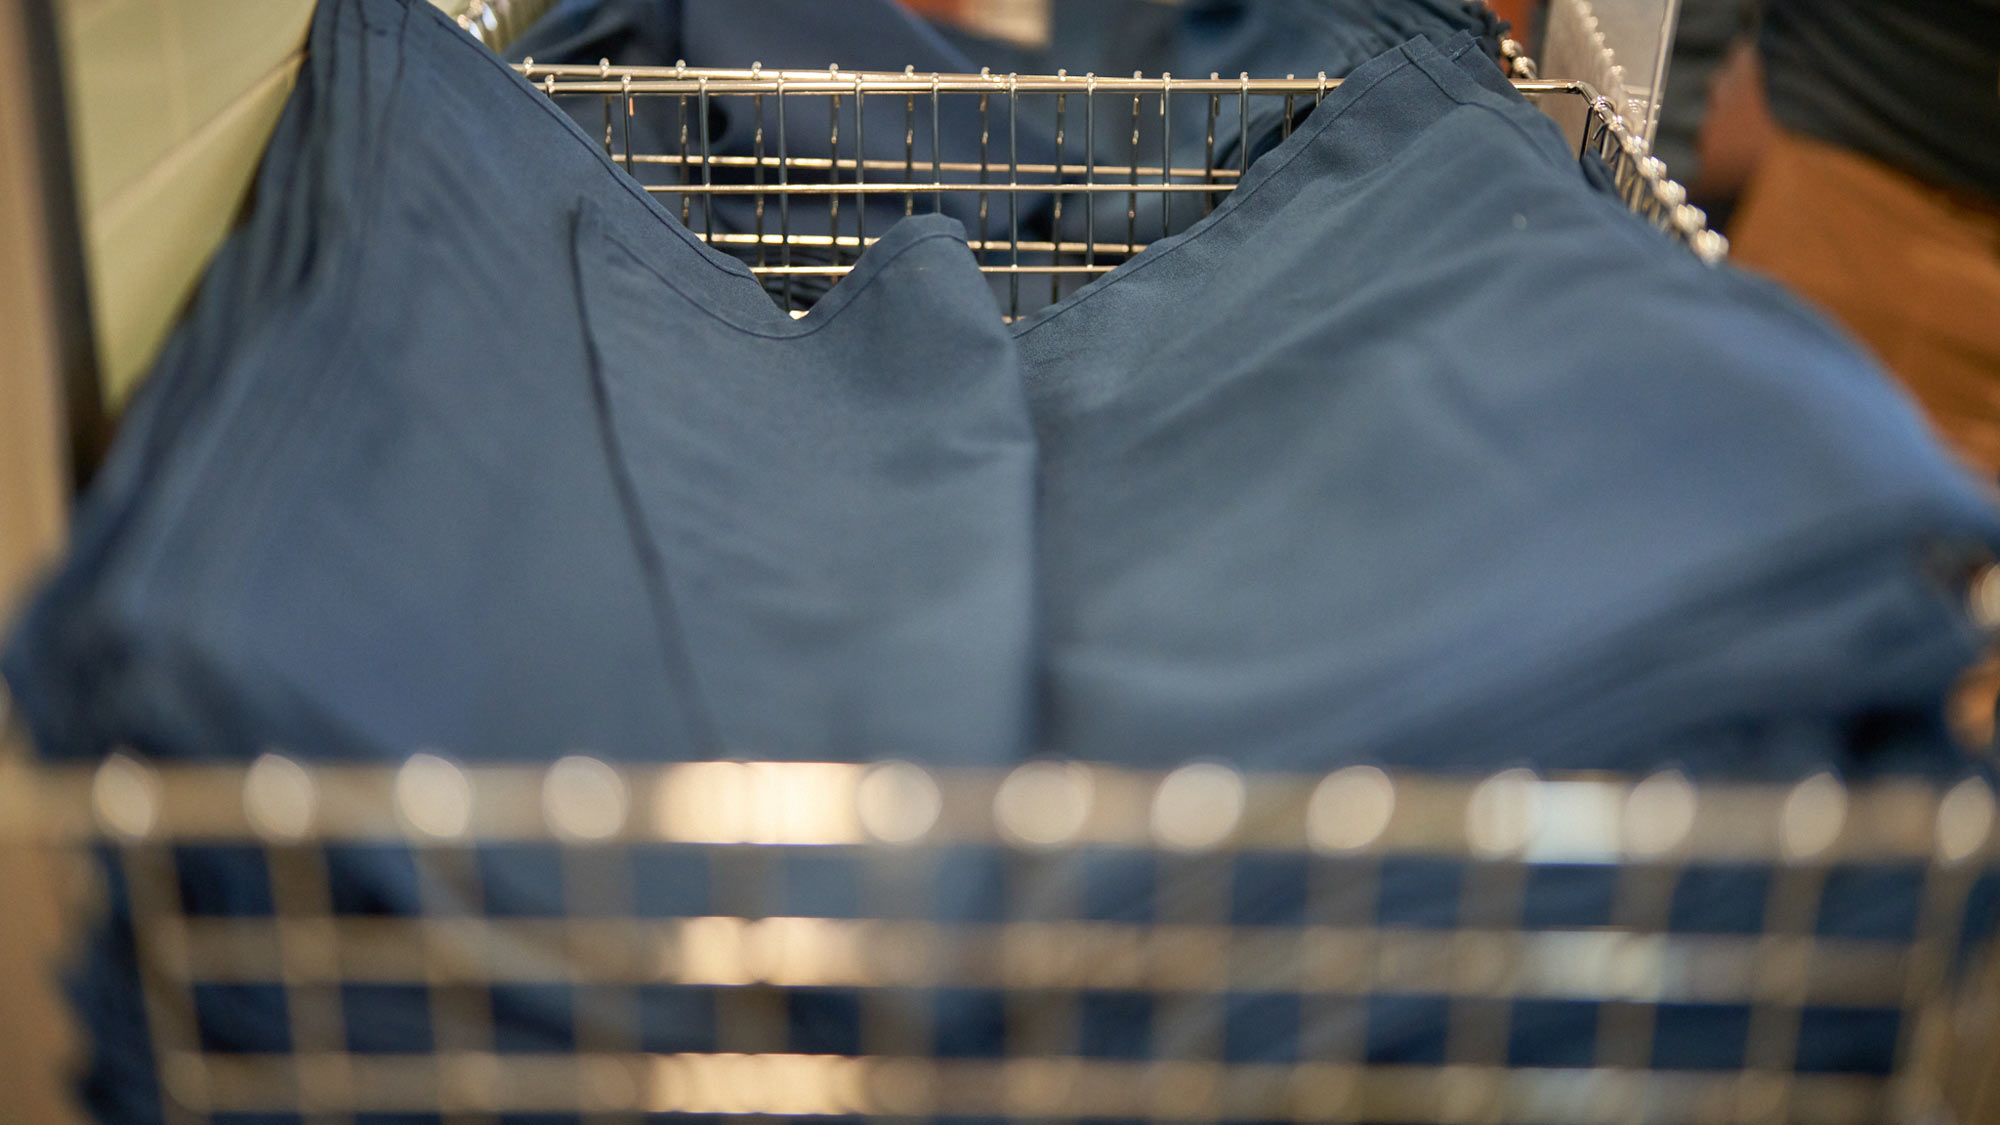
[{"x1": 518, "y1": 42, "x2": 1728, "y2": 316}]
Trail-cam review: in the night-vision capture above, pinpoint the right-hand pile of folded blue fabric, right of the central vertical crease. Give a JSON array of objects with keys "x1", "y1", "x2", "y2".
[{"x1": 1018, "y1": 30, "x2": 2000, "y2": 775}]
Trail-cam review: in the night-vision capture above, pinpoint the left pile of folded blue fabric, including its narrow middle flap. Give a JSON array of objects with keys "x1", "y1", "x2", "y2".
[{"x1": 4, "y1": 0, "x2": 1034, "y2": 1121}]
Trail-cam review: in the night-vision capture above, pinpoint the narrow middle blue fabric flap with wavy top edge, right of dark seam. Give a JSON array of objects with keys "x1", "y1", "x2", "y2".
[{"x1": 576, "y1": 212, "x2": 1034, "y2": 761}]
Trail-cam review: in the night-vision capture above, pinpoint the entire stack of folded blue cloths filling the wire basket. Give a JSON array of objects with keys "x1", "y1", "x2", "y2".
[{"x1": 4, "y1": 0, "x2": 2000, "y2": 1121}]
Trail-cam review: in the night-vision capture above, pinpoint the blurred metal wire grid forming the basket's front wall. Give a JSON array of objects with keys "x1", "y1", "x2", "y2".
[{"x1": 27, "y1": 751, "x2": 1996, "y2": 1123}]
